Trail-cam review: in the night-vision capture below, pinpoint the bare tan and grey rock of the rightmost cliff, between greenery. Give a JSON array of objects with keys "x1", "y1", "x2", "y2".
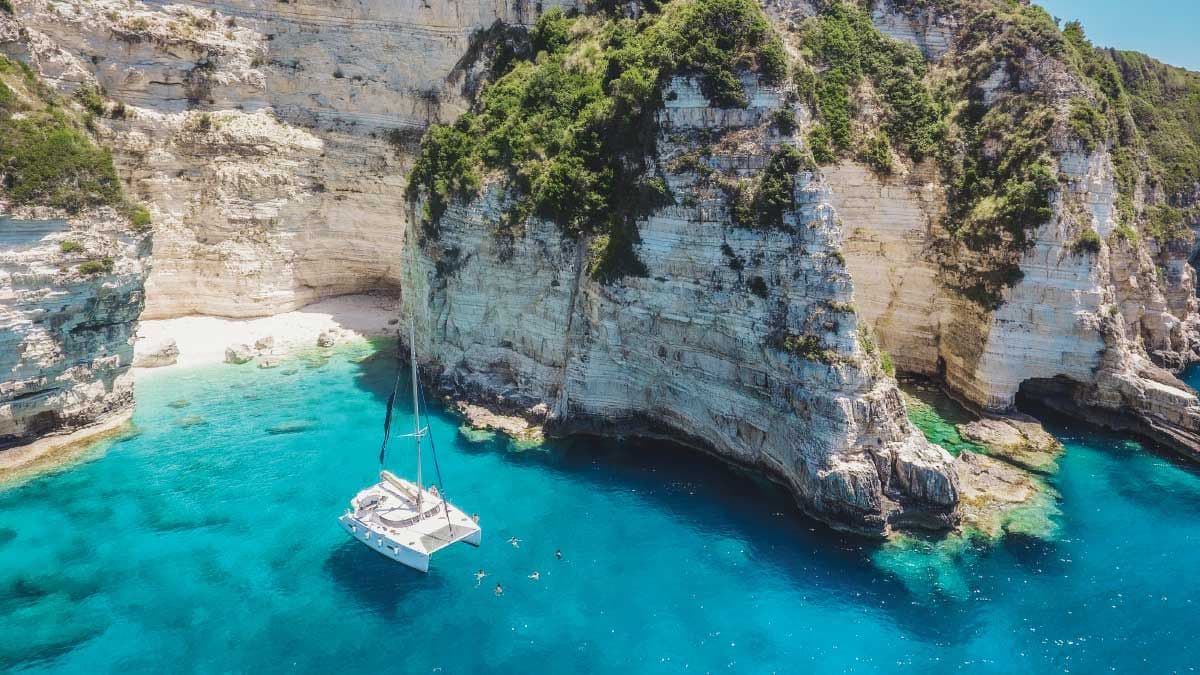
[{"x1": 827, "y1": 2, "x2": 1200, "y2": 456}]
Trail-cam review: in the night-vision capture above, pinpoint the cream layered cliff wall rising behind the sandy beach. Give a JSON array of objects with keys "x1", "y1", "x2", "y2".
[{"x1": 0, "y1": 0, "x2": 571, "y2": 318}]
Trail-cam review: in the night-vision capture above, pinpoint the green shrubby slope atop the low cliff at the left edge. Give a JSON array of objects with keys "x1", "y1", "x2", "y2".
[{"x1": 0, "y1": 56, "x2": 149, "y2": 223}]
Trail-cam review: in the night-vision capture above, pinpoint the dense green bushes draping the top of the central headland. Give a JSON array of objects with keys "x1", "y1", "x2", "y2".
[{"x1": 407, "y1": 0, "x2": 787, "y2": 282}]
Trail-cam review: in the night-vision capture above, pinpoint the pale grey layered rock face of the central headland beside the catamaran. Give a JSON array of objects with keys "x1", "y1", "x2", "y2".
[{"x1": 404, "y1": 78, "x2": 958, "y2": 532}]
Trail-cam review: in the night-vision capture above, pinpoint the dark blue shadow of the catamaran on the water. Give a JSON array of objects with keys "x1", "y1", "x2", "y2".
[{"x1": 324, "y1": 540, "x2": 445, "y2": 617}]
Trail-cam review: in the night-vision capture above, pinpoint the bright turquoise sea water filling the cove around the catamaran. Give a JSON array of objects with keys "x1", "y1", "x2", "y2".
[{"x1": 0, "y1": 343, "x2": 1200, "y2": 673}]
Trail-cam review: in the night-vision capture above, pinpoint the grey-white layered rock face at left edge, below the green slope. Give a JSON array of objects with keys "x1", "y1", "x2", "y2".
[{"x1": 0, "y1": 210, "x2": 149, "y2": 449}]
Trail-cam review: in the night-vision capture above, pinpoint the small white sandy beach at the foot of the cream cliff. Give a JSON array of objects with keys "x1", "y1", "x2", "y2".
[{"x1": 134, "y1": 294, "x2": 398, "y2": 375}]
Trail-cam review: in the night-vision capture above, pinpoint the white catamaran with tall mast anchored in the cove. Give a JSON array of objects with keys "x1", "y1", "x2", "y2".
[{"x1": 338, "y1": 317, "x2": 484, "y2": 572}]
